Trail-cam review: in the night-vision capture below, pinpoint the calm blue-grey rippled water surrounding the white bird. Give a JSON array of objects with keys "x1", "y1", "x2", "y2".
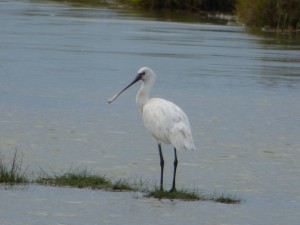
[{"x1": 0, "y1": 1, "x2": 300, "y2": 225}]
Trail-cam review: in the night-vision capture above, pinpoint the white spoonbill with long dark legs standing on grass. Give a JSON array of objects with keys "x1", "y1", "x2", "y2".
[{"x1": 107, "y1": 67, "x2": 196, "y2": 192}]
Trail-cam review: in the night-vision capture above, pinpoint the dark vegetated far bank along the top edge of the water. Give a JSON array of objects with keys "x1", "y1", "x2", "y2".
[{"x1": 46, "y1": 0, "x2": 300, "y2": 31}]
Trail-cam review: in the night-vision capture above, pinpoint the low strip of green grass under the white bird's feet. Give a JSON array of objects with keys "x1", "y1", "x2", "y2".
[{"x1": 0, "y1": 151, "x2": 241, "y2": 204}]
